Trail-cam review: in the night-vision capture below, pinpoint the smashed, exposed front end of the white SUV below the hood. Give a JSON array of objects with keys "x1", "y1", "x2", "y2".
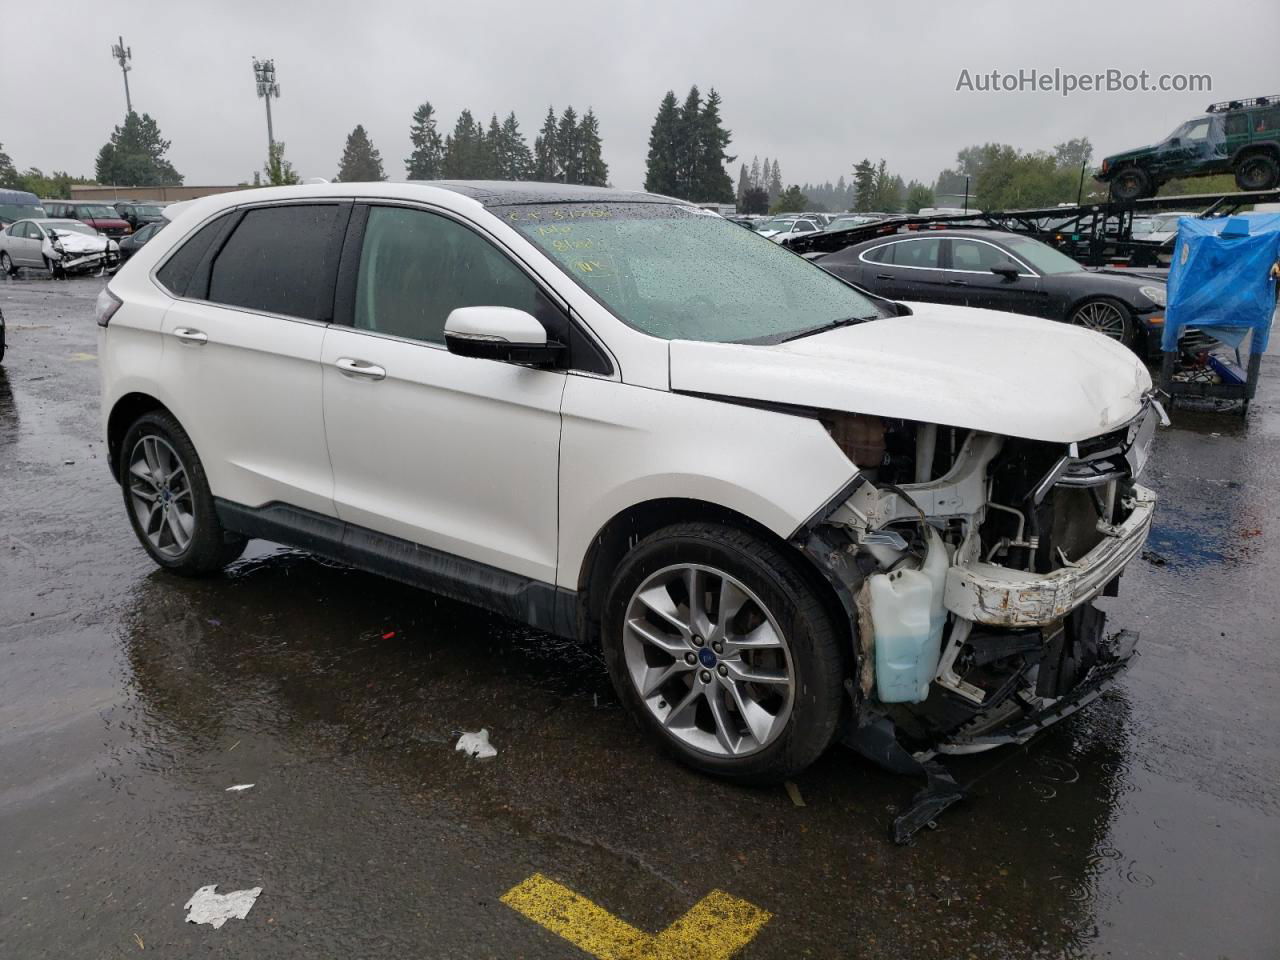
[{"x1": 794, "y1": 398, "x2": 1164, "y2": 834}]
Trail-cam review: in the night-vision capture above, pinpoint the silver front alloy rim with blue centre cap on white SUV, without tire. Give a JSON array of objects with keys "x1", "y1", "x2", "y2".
[{"x1": 622, "y1": 563, "x2": 795, "y2": 758}]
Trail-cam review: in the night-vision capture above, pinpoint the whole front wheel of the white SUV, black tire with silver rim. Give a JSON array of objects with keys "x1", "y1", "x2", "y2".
[{"x1": 602, "y1": 524, "x2": 845, "y2": 783}]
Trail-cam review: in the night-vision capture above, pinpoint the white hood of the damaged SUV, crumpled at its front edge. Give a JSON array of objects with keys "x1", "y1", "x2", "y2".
[{"x1": 671, "y1": 303, "x2": 1151, "y2": 443}]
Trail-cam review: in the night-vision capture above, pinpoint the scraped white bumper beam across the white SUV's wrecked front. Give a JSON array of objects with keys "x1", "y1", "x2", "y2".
[{"x1": 945, "y1": 486, "x2": 1156, "y2": 627}]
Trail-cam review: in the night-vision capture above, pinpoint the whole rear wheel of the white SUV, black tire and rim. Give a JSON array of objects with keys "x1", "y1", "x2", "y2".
[{"x1": 118, "y1": 411, "x2": 247, "y2": 576}]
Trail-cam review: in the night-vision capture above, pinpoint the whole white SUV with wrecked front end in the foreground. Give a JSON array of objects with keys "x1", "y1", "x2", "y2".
[{"x1": 97, "y1": 182, "x2": 1157, "y2": 780}]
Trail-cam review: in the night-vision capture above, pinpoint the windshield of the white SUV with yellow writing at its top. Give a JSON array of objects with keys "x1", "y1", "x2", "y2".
[{"x1": 492, "y1": 202, "x2": 881, "y2": 343}]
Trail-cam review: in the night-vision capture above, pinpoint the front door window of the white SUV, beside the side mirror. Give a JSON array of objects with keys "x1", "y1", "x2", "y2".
[{"x1": 355, "y1": 206, "x2": 552, "y2": 343}]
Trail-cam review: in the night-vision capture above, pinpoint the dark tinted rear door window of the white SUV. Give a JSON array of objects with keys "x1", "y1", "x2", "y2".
[{"x1": 209, "y1": 204, "x2": 346, "y2": 320}]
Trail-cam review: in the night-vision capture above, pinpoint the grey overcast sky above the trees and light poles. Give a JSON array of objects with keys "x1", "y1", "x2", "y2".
[{"x1": 0, "y1": 0, "x2": 1280, "y2": 187}]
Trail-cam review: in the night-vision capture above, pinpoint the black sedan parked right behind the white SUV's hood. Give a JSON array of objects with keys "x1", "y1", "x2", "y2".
[{"x1": 814, "y1": 229, "x2": 1165, "y2": 352}]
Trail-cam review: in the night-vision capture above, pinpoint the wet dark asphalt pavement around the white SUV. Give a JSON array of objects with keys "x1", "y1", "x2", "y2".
[{"x1": 0, "y1": 273, "x2": 1280, "y2": 960}]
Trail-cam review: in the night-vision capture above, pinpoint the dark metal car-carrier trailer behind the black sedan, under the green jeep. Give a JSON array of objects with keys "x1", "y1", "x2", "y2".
[{"x1": 783, "y1": 189, "x2": 1280, "y2": 268}]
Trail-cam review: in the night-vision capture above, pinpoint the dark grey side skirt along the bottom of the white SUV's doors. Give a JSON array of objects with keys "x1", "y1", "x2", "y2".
[{"x1": 214, "y1": 497, "x2": 577, "y2": 639}]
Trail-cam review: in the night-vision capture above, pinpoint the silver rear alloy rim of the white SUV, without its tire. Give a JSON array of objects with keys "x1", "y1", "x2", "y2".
[{"x1": 128, "y1": 434, "x2": 196, "y2": 557}]
